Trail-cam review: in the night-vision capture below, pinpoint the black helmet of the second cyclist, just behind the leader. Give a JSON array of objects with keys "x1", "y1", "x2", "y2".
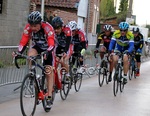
[{"x1": 52, "y1": 17, "x2": 64, "y2": 29}]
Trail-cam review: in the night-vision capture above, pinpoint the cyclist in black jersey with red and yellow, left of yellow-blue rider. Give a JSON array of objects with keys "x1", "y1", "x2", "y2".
[{"x1": 94, "y1": 24, "x2": 113, "y2": 82}]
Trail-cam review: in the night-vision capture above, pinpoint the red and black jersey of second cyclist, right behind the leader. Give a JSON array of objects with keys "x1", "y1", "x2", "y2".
[{"x1": 55, "y1": 26, "x2": 71, "y2": 55}]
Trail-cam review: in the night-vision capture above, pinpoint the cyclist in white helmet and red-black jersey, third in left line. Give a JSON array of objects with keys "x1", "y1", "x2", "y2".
[{"x1": 68, "y1": 21, "x2": 87, "y2": 66}]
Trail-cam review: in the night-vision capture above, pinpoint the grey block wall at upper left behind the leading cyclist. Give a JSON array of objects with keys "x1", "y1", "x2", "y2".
[{"x1": 0, "y1": 0, "x2": 30, "y2": 46}]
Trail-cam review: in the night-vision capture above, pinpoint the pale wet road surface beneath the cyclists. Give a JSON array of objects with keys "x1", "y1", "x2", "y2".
[{"x1": 0, "y1": 61, "x2": 150, "y2": 116}]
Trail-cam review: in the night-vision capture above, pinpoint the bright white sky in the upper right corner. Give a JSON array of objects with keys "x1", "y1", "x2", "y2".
[{"x1": 132, "y1": 0, "x2": 150, "y2": 25}]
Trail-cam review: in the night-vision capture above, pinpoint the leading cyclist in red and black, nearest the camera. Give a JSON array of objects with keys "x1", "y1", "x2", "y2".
[{"x1": 13, "y1": 11, "x2": 55, "y2": 109}]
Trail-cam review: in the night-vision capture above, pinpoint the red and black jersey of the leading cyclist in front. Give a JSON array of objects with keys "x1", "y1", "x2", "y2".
[{"x1": 18, "y1": 22, "x2": 54, "y2": 52}]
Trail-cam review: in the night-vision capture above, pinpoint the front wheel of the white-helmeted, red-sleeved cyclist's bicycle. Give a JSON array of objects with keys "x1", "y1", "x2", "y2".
[{"x1": 74, "y1": 73, "x2": 82, "y2": 92}]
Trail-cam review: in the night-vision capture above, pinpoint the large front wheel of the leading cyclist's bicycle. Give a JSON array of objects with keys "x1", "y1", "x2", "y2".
[{"x1": 20, "y1": 74, "x2": 38, "y2": 116}]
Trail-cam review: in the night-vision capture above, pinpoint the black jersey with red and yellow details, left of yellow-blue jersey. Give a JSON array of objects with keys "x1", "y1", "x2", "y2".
[{"x1": 96, "y1": 32, "x2": 113, "y2": 49}]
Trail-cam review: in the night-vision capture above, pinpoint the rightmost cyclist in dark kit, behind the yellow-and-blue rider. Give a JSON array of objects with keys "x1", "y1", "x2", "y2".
[{"x1": 132, "y1": 27, "x2": 144, "y2": 76}]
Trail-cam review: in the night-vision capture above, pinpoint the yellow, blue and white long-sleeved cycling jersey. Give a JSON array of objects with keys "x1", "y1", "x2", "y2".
[{"x1": 109, "y1": 30, "x2": 134, "y2": 53}]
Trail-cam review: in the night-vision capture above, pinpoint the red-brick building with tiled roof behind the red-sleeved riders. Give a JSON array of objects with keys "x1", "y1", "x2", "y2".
[{"x1": 31, "y1": 0, "x2": 100, "y2": 44}]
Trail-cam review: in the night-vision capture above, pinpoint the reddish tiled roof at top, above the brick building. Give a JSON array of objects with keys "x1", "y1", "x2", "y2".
[{"x1": 32, "y1": 0, "x2": 80, "y2": 8}]
